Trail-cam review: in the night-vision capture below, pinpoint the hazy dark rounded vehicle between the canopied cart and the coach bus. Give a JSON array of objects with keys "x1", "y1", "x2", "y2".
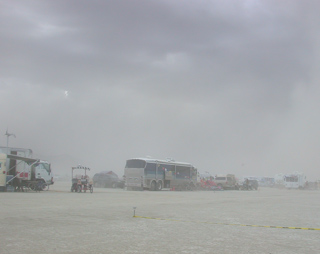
[{"x1": 92, "y1": 171, "x2": 124, "y2": 188}]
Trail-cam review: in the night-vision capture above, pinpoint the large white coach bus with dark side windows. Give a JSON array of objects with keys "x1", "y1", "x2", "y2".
[{"x1": 124, "y1": 158, "x2": 197, "y2": 191}]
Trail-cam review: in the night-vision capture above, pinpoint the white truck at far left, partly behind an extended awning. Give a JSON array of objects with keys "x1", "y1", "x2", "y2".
[{"x1": 0, "y1": 147, "x2": 53, "y2": 189}]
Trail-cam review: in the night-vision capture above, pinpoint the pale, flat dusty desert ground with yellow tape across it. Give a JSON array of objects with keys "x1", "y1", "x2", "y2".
[{"x1": 0, "y1": 182, "x2": 320, "y2": 254}]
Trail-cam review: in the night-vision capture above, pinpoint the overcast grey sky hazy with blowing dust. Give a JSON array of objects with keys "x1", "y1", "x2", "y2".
[{"x1": 0, "y1": 0, "x2": 320, "y2": 180}]
